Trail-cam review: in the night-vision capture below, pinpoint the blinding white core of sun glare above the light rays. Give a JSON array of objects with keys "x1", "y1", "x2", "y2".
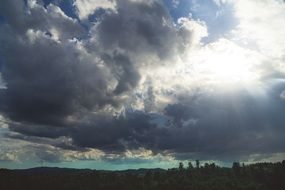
[{"x1": 193, "y1": 42, "x2": 258, "y2": 84}]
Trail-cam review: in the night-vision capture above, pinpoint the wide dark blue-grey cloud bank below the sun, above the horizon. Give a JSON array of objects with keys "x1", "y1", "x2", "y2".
[{"x1": 8, "y1": 83, "x2": 285, "y2": 160}]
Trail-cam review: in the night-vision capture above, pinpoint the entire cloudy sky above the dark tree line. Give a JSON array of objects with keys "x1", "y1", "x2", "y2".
[{"x1": 0, "y1": 0, "x2": 285, "y2": 170}]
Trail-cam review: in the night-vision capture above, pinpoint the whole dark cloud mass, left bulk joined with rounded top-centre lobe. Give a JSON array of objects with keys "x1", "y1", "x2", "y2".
[{"x1": 0, "y1": 1, "x2": 184, "y2": 125}]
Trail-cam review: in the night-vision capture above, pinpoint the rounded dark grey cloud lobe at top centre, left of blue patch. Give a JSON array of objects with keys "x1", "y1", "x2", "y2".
[{"x1": 93, "y1": 0, "x2": 182, "y2": 59}]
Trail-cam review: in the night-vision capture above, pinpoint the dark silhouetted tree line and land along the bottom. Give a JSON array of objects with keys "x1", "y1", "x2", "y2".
[{"x1": 0, "y1": 160, "x2": 285, "y2": 190}]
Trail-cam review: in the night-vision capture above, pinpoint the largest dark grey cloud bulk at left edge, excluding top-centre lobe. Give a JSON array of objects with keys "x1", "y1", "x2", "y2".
[{"x1": 0, "y1": 1, "x2": 114, "y2": 124}]
